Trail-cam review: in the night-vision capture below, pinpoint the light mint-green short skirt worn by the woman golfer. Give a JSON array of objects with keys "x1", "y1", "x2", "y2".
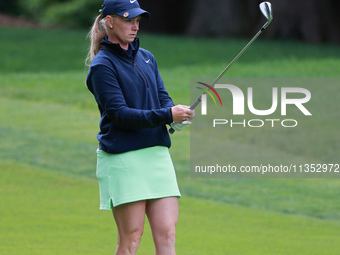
[{"x1": 96, "y1": 146, "x2": 181, "y2": 210}]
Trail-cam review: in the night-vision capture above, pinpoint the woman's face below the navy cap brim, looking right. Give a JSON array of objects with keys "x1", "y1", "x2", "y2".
[{"x1": 106, "y1": 15, "x2": 141, "y2": 50}]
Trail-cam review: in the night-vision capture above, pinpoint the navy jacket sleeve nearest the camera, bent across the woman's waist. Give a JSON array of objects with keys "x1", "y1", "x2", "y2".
[{"x1": 90, "y1": 65, "x2": 172, "y2": 130}]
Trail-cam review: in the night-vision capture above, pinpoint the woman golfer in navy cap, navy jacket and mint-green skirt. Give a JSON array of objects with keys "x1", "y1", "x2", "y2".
[{"x1": 86, "y1": 0, "x2": 194, "y2": 255}]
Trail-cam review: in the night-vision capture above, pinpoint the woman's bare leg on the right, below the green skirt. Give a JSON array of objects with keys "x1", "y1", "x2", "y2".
[{"x1": 146, "y1": 197, "x2": 178, "y2": 255}]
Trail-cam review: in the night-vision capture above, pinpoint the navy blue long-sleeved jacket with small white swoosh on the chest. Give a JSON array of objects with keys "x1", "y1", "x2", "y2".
[{"x1": 86, "y1": 38, "x2": 174, "y2": 154}]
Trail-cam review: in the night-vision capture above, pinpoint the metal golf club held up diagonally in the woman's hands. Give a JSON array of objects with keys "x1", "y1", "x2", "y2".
[{"x1": 169, "y1": 2, "x2": 273, "y2": 134}]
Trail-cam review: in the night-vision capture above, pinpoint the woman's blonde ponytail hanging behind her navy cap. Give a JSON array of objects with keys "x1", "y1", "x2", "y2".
[{"x1": 85, "y1": 13, "x2": 107, "y2": 66}]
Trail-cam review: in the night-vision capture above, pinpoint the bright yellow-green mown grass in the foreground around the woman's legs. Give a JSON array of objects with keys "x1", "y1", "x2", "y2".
[{"x1": 0, "y1": 162, "x2": 340, "y2": 255}]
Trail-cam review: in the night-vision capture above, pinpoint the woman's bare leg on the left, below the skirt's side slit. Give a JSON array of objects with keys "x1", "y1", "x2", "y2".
[{"x1": 112, "y1": 201, "x2": 146, "y2": 255}]
